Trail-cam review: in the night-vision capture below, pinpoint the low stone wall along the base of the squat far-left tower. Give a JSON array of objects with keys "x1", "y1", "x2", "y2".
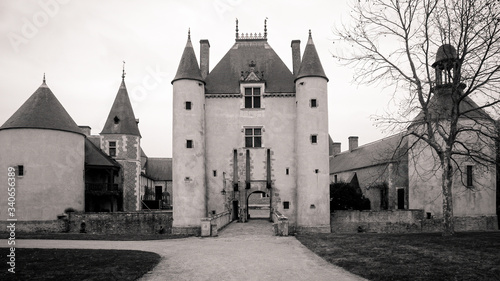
[{"x1": 0, "y1": 219, "x2": 68, "y2": 233}]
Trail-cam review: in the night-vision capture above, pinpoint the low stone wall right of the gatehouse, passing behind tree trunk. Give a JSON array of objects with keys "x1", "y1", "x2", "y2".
[{"x1": 330, "y1": 210, "x2": 498, "y2": 233}]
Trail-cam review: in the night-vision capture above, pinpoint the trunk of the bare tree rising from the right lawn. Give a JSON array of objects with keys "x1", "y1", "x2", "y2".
[{"x1": 442, "y1": 155, "x2": 455, "y2": 236}]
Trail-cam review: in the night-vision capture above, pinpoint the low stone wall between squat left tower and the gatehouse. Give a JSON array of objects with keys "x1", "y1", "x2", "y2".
[{"x1": 69, "y1": 211, "x2": 172, "y2": 234}]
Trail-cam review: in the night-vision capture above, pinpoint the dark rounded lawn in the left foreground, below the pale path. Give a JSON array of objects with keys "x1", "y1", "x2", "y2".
[{"x1": 0, "y1": 248, "x2": 160, "y2": 281}]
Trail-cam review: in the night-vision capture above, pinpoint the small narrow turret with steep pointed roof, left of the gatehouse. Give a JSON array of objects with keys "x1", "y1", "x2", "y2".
[{"x1": 100, "y1": 70, "x2": 141, "y2": 211}]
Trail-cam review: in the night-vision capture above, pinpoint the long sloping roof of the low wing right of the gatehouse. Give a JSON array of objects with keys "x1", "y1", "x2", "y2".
[{"x1": 330, "y1": 133, "x2": 408, "y2": 174}]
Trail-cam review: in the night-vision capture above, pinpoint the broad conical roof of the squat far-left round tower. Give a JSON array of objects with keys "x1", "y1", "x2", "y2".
[{"x1": 0, "y1": 77, "x2": 84, "y2": 135}]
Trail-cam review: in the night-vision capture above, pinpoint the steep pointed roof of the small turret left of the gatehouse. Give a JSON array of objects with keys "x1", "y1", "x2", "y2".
[{"x1": 101, "y1": 76, "x2": 141, "y2": 137}]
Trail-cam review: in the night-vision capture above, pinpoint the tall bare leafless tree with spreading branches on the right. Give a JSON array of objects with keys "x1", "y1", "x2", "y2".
[{"x1": 334, "y1": 0, "x2": 500, "y2": 235}]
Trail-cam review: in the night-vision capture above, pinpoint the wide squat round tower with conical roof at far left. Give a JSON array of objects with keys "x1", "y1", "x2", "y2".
[{"x1": 0, "y1": 76, "x2": 85, "y2": 221}]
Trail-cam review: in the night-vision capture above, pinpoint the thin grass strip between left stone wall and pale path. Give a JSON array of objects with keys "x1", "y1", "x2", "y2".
[{"x1": 6, "y1": 232, "x2": 192, "y2": 241}]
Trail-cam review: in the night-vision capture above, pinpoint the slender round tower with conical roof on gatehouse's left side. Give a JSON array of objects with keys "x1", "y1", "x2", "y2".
[{"x1": 172, "y1": 30, "x2": 207, "y2": 233}]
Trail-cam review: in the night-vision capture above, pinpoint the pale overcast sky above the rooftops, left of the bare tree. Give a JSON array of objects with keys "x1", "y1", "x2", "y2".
[{"x1": 0, "y1": 0, "x2": 398, "y2": 157}]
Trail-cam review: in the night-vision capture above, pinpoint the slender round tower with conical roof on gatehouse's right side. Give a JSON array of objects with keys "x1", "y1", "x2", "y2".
[{"x1": 295, "y1": 31, "x2": 330, "y2": 232}]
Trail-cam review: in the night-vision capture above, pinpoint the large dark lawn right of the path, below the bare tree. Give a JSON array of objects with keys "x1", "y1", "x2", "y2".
[{"x1": 296, "y1": 232, "x2": 500, "y2": 280}]
